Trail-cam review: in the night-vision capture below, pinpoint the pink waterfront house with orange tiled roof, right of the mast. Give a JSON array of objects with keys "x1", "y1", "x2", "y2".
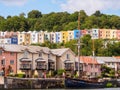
[{"x1": 80, "y1": 56, "x2": 101, "y2": 78}]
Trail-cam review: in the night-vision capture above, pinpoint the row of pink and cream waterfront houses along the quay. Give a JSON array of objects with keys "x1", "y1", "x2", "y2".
[{"x1": 0, "y1": 45, "x2": 120, "y2": 77}]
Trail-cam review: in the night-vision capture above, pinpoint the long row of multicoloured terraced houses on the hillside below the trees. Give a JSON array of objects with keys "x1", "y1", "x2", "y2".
[{"x1": 0, "y1": 29, "x2": 120, "y2": 45}]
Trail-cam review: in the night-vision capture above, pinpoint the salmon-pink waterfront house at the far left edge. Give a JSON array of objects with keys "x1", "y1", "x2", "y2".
[{"x1": 0, "y1": 47, "x2": 17, "y2": 76}]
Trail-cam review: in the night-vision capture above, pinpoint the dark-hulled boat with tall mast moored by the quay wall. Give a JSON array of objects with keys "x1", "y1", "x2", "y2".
[{"x1": 65, "y1": 14, "x2": 105, "y2": 89}]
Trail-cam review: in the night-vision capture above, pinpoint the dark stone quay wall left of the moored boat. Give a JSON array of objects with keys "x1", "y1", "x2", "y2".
[{"x1": 5, "y1": 77, "x2": 64, "y2": 89}]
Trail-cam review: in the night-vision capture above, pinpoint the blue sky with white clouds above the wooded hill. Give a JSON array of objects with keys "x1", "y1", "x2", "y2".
[{"x1": 0, "y1": 0, "x2": 120, "y2": 17}]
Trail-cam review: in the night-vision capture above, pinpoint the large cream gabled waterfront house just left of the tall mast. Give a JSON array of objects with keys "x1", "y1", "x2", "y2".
[{"x1": 51, "y1": 48, "x2": 75, "y2": 72}]
